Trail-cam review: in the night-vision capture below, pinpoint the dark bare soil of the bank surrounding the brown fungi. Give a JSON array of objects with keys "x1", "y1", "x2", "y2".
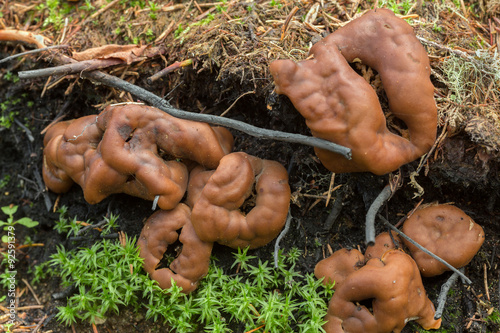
[{"x1": 0, "y1": 1, "x2": 500, "y2": 332}]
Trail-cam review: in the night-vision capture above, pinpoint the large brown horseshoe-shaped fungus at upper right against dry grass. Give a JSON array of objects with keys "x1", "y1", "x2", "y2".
[{"x1": 270, "y1": 9, "x2": 437, "y2": 175}]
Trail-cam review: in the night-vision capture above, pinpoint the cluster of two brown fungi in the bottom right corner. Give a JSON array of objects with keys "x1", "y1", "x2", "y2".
[{"x1": 314, "y1": 204, "x2": 484, "y2": 333}]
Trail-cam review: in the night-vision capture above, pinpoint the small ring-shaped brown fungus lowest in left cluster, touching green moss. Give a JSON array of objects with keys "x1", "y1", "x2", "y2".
[{"x1": 137, "y1": 204, "x2": 212, "y2": 293}]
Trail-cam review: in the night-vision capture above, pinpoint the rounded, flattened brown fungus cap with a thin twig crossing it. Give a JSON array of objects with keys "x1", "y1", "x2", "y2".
[{"x1": 402, "y1": 204, "x2": 485, "y2": 277}]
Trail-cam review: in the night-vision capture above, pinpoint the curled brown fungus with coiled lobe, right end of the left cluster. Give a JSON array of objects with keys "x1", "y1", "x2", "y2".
[{"x1": 188, "y1": 152, "x2": 290, "y2": 248}]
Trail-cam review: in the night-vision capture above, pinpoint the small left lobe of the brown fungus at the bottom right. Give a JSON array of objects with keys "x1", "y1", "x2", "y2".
[{"x1": 314, "y1": 249, "x2": 365, "y2": 289}]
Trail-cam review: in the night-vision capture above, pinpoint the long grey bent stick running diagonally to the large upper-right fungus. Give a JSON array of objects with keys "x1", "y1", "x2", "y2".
[{"x1": 78, "y1": 71, "x2": 351, "y2": 159}]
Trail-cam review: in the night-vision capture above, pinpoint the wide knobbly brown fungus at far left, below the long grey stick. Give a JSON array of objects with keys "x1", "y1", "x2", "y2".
[{"x1": 44, "y1": 104, "x2": 233, "y2": 209}]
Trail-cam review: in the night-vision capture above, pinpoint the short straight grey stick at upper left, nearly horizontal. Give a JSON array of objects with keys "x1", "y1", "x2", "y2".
[{"x1": 18, "y1": 59, "x2": 123, "y2": 79}]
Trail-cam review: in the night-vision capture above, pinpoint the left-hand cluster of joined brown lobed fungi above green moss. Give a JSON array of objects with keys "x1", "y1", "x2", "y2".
[{"x1": 43, "y1": 104, "x2": 290, "y2": 293}]
